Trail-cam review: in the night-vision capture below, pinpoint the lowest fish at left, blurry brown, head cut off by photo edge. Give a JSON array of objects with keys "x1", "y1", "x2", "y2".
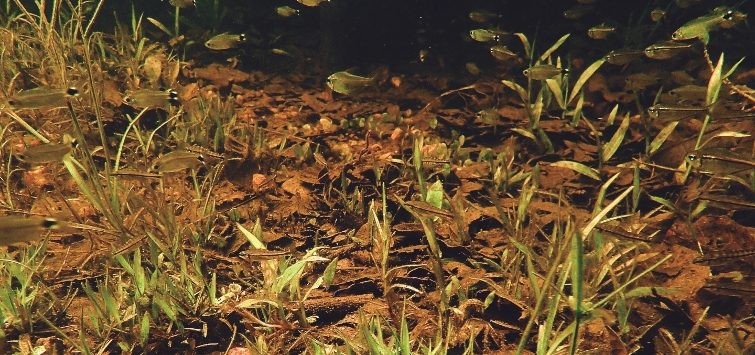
[{"x1": 0, "y1": 216, "x2": 64, "y2": 246}]
